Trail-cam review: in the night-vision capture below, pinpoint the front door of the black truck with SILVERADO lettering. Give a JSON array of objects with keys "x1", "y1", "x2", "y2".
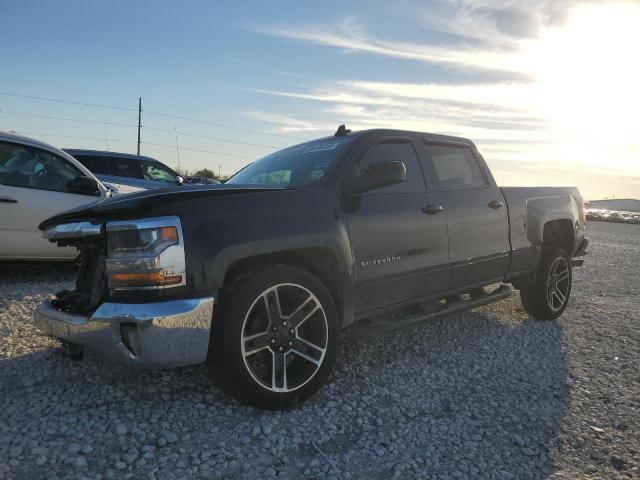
[{"x1": 343, "y1": 137, "x2": 449, "y2": 313}]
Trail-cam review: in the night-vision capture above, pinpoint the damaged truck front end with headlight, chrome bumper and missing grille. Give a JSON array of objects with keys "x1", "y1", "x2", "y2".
[{"x1": 34, "y1": 216, "x2": 214, "y2": 368}]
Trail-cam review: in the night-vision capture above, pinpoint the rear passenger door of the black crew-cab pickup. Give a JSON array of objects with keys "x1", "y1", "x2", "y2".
[{"x1": 421, "y1": 140, "x2": 509, "y2": 289}]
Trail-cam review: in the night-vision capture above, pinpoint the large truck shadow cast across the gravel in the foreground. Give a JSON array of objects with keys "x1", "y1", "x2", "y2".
[{"x1": 0, "y1": 304, "x2": 570, "y2": 479}]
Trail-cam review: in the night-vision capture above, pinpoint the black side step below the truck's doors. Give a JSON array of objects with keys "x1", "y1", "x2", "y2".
[{"x1": 351, "y1": 285, "x2": 513, "y2": 339}]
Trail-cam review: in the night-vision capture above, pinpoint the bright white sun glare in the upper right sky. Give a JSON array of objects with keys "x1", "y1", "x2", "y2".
[{"x1": 531, "y1": 3, "x2": 640, "y2": 144}]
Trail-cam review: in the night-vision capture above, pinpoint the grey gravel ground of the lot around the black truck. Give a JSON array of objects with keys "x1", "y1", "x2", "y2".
[{"x1": 0, "y1": 223, "x2": 640, "y2": 479}]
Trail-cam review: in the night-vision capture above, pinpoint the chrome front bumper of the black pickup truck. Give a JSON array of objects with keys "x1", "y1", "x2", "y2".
[{"x1": 34, "y1": 297, "x2": 214, "y2": 368}]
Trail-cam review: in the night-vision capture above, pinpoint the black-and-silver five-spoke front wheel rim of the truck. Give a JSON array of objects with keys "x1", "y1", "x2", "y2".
[{"x1": 240, "y1": 283, "x2": 329, "y2": 393}]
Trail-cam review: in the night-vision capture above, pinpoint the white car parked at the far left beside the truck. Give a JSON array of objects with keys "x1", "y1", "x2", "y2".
[{"x1": 0, "y1": 132, "x2": 109, "y2": 260}]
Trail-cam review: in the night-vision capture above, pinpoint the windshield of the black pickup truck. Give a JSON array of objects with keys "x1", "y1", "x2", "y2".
[{"x1": 225, "y1": 137, "x2": 353, "y2": 187}]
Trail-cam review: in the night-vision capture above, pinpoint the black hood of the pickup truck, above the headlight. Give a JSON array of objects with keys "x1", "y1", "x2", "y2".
[{"x1": 38, "y1": 183, "x2": 290, "y2": 230}]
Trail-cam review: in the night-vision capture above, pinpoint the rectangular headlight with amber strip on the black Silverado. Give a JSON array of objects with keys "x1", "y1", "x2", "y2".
[{"x1": 106, "y1": 217, "x2": 186, "y2": 290}]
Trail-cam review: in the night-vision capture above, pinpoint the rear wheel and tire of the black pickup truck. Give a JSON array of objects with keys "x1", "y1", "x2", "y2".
[{"x1": 520, "y1": 247, "x2": 573, "y2": 320}]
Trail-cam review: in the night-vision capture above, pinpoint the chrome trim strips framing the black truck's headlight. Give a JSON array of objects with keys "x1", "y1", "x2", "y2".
[{"x1": 105, "y1": 216, "x2": 187, "y2": 292}]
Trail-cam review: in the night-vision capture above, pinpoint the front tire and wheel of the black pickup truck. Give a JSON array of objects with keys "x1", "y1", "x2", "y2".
[{"x1": 207, "y1": 265, "x2": 338, "y2": 410}]
